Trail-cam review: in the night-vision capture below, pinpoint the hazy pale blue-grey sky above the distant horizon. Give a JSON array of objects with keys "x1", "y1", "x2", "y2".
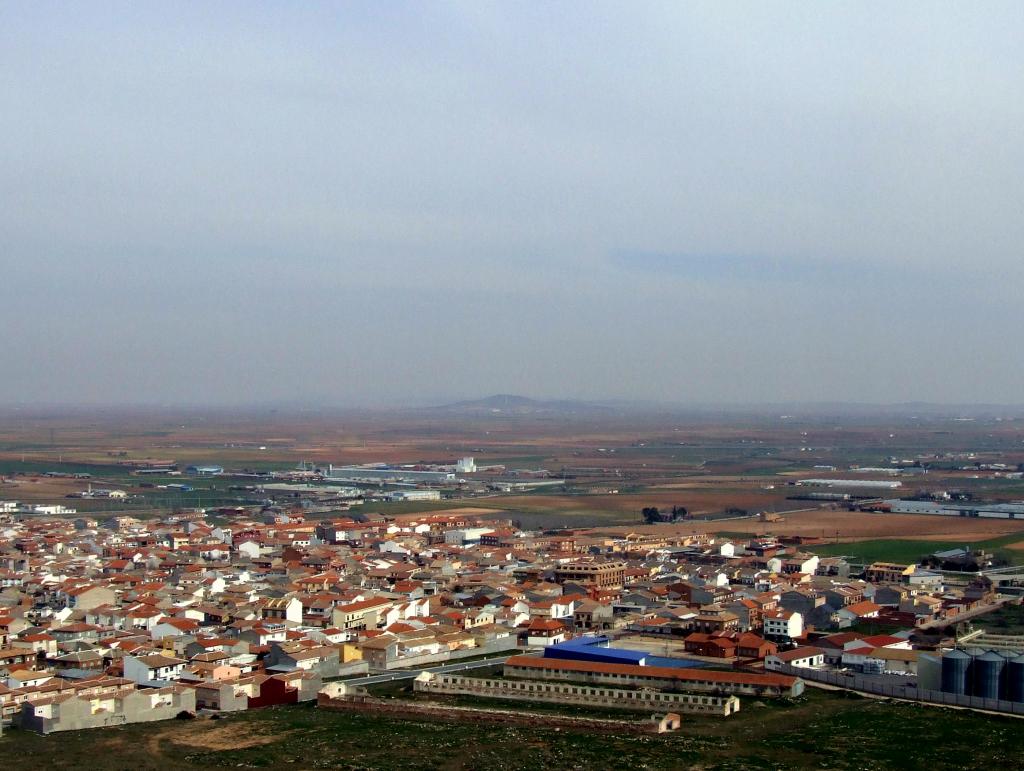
[{"x1": 0, "y1": 0, "x2": 1024, "y2": 404}]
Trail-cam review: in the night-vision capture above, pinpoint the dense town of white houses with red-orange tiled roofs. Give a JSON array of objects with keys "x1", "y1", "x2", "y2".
[{"x1": 0, "y1": 460, "x2": 1024, "y2": 734}]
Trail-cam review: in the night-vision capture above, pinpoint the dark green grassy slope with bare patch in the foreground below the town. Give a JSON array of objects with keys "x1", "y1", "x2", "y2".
[{"x1": 0, "y1": 689, "x2": 1024, "y2": 771}]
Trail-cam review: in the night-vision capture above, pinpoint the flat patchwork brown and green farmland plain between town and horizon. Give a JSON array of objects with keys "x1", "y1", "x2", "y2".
[{"x1": 6, "y1": 410, "x2": 1024, "y2": 543}]
